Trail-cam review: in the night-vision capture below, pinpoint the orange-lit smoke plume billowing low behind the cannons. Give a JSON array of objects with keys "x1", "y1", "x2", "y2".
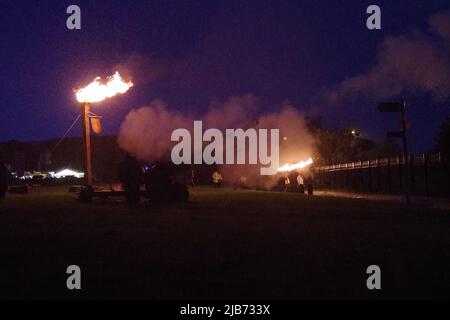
[{"x1": 118, "y1": 95, "x2": 314, "y2": 186}]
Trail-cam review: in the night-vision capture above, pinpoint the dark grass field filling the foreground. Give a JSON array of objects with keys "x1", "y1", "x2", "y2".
[{"x1": 0, "y1": 188, "x2": 450, "y2": 299}]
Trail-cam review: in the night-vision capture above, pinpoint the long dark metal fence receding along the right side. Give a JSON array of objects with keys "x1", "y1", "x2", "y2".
[{"x1": 315, "y1": 153, "x2": 450, "y2": 197}]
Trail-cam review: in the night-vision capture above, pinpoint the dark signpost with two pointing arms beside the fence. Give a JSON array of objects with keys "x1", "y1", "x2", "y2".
[{"x1": 378, "y1": 100, "x2": 411, "y2": 210}]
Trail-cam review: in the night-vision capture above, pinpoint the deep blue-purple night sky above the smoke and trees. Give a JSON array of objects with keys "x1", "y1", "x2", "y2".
[{"x1": 0, "y1": 0, "x2": 450, "y2": 152}]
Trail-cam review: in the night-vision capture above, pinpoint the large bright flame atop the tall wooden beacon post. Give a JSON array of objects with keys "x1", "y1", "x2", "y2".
[{"x1": 75, "y1": 71, "x2": 133, "y2": 103}]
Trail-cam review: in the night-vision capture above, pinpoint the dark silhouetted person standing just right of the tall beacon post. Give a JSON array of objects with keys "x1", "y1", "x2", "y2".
[{"x1": 119, "y1": 153, "x2": 143, "y2": 207}]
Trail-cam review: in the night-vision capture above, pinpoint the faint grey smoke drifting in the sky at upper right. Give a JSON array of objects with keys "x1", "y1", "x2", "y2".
[{"x1": 330, "y1": 12, "x2": 450, "y2": 103}]
